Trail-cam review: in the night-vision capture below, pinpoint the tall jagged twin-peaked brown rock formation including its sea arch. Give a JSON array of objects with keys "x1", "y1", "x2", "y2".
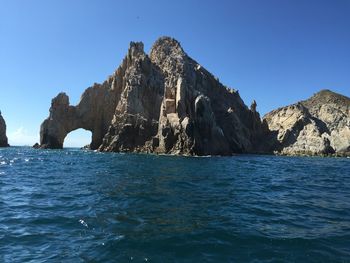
[{"x1": 40, "y1": 37, "x2": 267, "y2": 155}]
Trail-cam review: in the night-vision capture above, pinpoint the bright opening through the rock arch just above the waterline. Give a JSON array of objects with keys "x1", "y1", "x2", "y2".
[{"x1": 63, "y1": 128, "x2": 92, "y2": 148}]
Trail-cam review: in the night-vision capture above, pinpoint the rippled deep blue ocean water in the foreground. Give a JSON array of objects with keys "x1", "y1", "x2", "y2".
[{"x1": 0, "y1": 147, "x2": 350, "y2": 262}]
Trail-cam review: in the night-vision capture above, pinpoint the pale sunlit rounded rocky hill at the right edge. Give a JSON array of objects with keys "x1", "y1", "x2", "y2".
[{"x1": 264, "y1": 90, "x2": 350, "y2": 156}]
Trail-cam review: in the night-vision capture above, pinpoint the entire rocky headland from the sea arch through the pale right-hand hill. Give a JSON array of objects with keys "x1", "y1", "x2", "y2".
[{"x1": 29, "y1": 37, "x2": 350, "y2": 156}]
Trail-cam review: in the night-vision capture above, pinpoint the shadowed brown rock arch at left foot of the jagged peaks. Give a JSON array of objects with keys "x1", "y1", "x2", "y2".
[{"x1": 40, "y1": 84, "x2": 115, "y2": 149}]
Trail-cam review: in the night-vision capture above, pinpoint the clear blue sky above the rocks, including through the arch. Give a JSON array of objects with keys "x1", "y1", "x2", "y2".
[{"x1": 0, "y1": 0, "x2": 350, "y2": 147}]
